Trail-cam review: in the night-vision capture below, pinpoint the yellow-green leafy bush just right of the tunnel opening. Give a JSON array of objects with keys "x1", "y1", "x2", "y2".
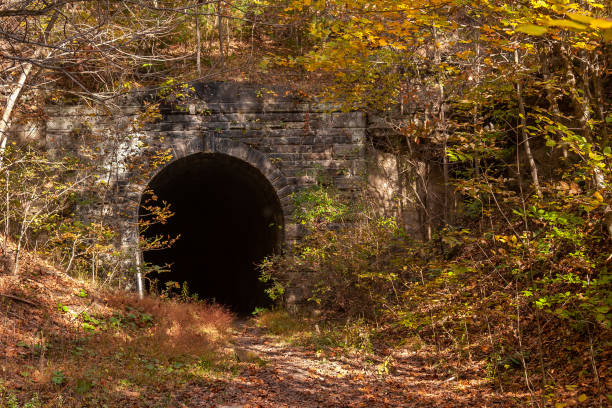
[{"x1": 261, "y1": 186, "x2": 406, "y2": 318}]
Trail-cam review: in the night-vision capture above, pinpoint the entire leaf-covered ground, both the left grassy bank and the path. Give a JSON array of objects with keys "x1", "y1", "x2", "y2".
[{"x1": 0, "y1": 250, "x2": 556, "y2": 408}]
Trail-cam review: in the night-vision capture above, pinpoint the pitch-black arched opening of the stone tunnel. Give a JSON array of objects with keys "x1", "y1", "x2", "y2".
[{"x1": 139, "y1": 153, "x2": 283, "y2": 315}]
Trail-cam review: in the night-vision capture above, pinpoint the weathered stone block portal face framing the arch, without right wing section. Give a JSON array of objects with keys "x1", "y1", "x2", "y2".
[{"x1": 44, "y1": 83, "x2": 367, "y2": 247}]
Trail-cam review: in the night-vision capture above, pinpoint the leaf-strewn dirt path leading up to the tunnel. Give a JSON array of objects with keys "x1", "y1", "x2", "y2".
[{"x1": 177, "y1": 323, "x2": 515, "y2": 408}]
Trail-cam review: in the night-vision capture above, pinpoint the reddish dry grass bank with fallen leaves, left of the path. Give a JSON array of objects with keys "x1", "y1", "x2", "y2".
[{"x1": 0, "y1": 247, "x2": 233, "y2": 408}]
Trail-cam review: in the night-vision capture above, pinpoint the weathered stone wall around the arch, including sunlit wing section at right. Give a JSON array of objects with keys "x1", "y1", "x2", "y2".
[{"x1": 23, "y1": 79, "x2": 444, "y2": 304}]
